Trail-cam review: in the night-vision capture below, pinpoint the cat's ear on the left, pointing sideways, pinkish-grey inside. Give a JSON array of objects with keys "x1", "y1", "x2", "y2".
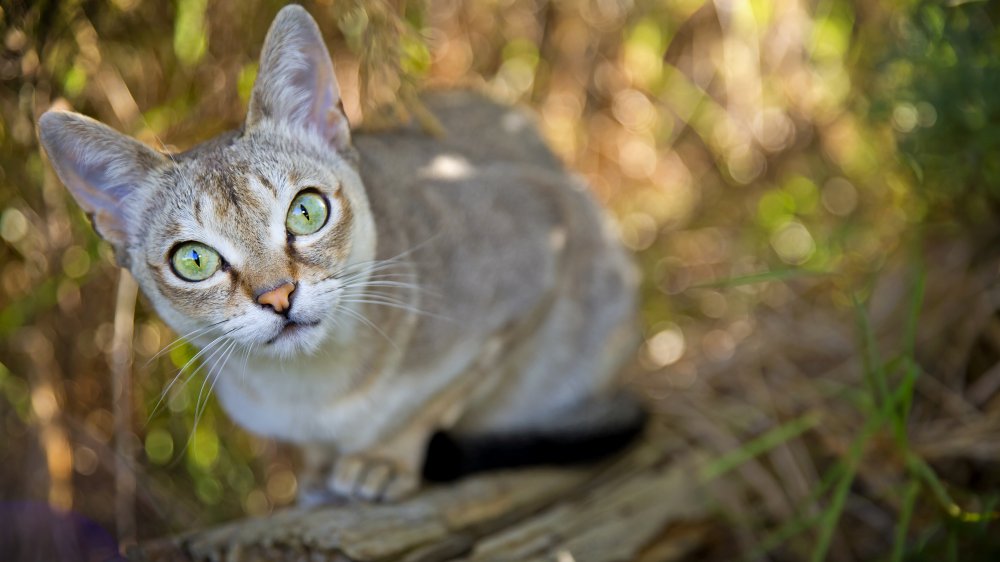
[{"x1": 38, "y1": 111, "x2": 166, "y2": 254}]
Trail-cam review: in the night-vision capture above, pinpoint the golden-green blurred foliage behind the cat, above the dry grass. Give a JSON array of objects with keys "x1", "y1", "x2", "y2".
[{"x1": 0, "y1": 0, "x2": 1000, "y2": 558}]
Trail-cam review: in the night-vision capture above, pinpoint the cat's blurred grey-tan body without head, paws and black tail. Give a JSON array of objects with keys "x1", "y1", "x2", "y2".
[{"x1": 218, "y1": 92, "x2": 634, "y2": 444}]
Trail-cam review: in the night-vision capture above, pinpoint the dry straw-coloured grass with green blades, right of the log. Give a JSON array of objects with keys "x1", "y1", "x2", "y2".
[{"x1": 637, "y1": 232, "x2": 1000, "y2": 560}]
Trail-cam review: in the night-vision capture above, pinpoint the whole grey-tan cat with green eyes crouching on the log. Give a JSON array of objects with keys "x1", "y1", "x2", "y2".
[{"x1": 39, "y1": 5, "x2": 641, "y2": 503}]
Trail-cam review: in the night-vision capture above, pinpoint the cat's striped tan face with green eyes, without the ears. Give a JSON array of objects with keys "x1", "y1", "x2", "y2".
[{"x1": 137, "y1": 128, "x2": 369, "y2": 356}]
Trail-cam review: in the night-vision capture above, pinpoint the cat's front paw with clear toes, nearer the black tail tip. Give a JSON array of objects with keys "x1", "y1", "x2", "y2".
[{"x1": 327, "y1": 453, "x2": 420, "y2": 502}]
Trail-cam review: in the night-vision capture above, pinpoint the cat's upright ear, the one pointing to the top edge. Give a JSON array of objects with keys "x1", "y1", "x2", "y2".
[{"x1": 246, "y1": 5, "x2": 351, "y2": 148}]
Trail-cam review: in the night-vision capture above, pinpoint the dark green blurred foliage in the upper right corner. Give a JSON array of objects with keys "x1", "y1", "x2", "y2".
[{"x1": 872, "y1": 0, "x2": 1000, "y2": 222}]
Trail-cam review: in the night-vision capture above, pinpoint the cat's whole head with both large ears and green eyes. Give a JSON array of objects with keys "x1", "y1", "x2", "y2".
[{"x1": 39, "y1": 6, "x2": 375, "y2": 356}]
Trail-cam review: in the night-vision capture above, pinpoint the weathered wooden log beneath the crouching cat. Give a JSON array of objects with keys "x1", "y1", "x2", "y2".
[{"x1": 129, "y1": 420, "x2": 710, "y2": 562}]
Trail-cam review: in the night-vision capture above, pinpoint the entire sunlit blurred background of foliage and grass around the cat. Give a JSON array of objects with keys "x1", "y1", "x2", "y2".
[{"x1": 0, "y1": 0, "x2": 1000, "y2": 560}]
